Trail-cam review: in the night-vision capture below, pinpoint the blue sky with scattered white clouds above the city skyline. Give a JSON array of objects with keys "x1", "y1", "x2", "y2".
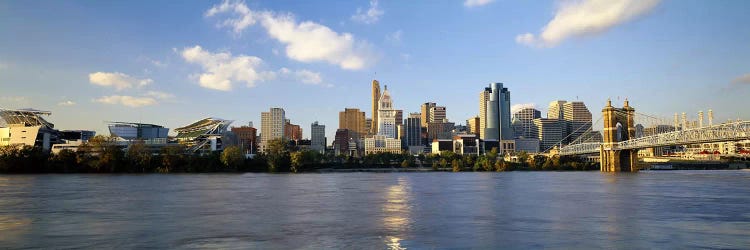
[{"x1": 0, "y1": 0, "x2": 750, "y2": 141}]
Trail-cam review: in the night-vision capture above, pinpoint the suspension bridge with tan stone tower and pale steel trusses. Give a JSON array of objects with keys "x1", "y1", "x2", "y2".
[{"x1": 559, "y1": 99, "x2": 750, "y2": 172}]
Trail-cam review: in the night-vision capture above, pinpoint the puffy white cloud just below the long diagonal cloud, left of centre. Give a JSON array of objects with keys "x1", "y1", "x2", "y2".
[{"x1": 182, "y1": 45, "x2": 274, "y2": 91}]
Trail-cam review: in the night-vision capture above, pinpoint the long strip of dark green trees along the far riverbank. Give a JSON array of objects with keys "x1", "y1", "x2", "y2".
[{"x1": 0, "y1": 136, "x2": 599, "y2": 173}]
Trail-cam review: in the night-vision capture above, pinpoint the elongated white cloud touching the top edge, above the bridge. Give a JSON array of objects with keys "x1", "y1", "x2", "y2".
[{"x1": 516, "y1": 0, "x2": 661, "y2": 47}]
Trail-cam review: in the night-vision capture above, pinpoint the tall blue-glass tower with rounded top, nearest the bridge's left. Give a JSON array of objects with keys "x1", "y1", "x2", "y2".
[{"x1": 484, "y1": 83, "x2": 513, "y2": 141}]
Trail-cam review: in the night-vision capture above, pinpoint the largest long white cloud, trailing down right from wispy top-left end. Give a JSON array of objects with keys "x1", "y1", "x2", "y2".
[{"x1": 205, "y1": 1, "x2": 375, "y2": 70}]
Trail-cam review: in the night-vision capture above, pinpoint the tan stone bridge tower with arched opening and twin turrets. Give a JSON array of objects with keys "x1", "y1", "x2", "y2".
[{"x1": 599, "y1": 99, "x2": 638, "y2": 172}]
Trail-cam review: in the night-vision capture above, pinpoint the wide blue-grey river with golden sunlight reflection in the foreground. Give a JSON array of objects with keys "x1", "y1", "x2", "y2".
[{"x1": 0, "y1": 171, "x2": 750, "y2": 249}]
